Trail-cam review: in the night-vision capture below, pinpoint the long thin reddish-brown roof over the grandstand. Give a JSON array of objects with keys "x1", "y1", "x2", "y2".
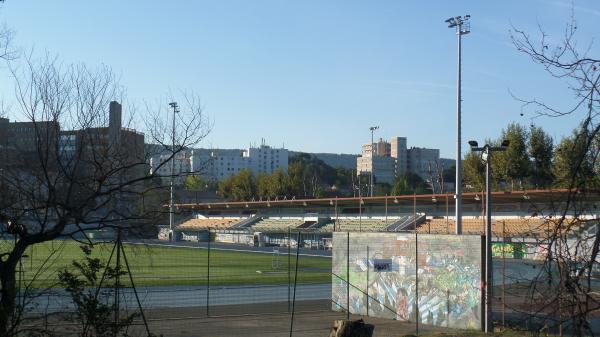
[{"x1": 174, "y1": 189, "x2": 600, "y2": 210}]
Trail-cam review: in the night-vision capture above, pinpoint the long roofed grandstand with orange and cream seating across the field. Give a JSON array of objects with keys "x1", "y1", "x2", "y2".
[{"x1": 168, "y1": 191, "x2": 600, "y2": 246}]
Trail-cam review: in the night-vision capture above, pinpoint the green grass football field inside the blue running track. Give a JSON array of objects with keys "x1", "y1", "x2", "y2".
[{"x1": 0, "y1": 240, "x2": 331, "y2": 288}]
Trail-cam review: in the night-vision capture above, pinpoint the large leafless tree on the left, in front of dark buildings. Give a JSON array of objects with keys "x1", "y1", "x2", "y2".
[{"x1": 0, "y1": 55, "x2": 210, "y2": 336}]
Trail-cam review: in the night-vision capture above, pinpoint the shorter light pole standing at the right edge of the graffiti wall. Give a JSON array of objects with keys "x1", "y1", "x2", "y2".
[{"x1": 469, "y1": 140, "x2": 509, "y2": 333}]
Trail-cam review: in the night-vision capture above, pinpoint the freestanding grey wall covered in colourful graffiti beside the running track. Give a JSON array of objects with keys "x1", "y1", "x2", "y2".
[{"x1": 332, "y1": 232, "x2": 482, "y2": 329}]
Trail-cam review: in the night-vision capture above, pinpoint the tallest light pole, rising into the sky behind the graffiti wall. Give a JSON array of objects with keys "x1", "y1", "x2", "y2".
[{"x1": 446, "y1": 14, "x2": 471, "y2": 234}]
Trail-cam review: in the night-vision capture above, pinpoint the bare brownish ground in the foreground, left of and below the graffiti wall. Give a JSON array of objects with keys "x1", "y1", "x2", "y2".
[{"x1": 130, "y1": 301, "x2": 441, "y2": 337}]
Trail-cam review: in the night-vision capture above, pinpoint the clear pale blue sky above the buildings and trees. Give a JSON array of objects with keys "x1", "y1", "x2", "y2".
[{"x1": 0, "y1": 0, "x2": 600, "y2": 157}]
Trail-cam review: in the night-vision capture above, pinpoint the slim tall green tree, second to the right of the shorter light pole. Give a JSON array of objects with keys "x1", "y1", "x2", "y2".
[{"x1": 528, "y1": 126, "x2": 554, "y2": 188}]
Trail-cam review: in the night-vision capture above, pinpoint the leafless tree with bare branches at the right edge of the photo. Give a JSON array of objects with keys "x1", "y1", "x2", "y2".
[{"x1": 511, "y1": 10, "x2": 600, "y2": 336}]
